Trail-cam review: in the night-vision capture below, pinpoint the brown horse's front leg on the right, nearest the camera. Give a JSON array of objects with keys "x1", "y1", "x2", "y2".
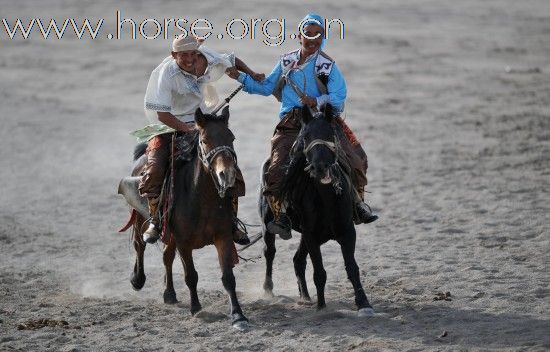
[{"x1": 214, "y1": 236, "x2": 248, "y2": 330}]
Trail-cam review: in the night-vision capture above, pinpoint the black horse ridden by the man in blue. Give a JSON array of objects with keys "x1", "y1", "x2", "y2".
[{"x1": 259, "y1": 105, "x2": 374, "y2": 316}]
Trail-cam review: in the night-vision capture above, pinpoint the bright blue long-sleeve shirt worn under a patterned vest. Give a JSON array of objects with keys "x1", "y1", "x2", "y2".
[{"x1": 238, "y1": 54, "x2": 347, "y2": 118}]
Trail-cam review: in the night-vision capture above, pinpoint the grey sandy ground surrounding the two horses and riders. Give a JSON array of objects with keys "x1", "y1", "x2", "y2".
[{"x1": 0, "y1": 0, "x2": 550, "y2": 351}]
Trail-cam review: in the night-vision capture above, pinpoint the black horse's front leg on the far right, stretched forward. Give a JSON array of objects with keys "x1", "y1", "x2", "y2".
[{"x1": 339, "y1": 224, "x2": 374, "y2": 316}]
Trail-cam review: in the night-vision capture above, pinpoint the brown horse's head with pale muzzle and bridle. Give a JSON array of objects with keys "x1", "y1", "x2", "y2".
[{"x1": 195, "y1": 106, "x2": 237, "y2": 198}]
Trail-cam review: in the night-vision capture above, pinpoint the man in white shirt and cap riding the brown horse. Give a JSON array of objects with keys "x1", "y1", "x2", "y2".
[{"x1": 139, "y1": 36, "x2": 263, "y2": 244}]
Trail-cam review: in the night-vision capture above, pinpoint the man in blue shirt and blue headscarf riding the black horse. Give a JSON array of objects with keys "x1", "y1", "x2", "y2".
[{"x1": 227, "y1": 14, "x2": 378, "y2": 239}]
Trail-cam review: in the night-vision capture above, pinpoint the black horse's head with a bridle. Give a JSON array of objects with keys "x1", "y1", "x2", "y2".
[{"x1": 297, "y1": 104, "x2": 338, "y2": 184}]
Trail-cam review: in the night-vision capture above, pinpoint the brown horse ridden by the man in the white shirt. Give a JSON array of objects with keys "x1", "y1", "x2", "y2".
[{"x1": 123, "y1": 107, "x2": 248, "y2": 329}]
